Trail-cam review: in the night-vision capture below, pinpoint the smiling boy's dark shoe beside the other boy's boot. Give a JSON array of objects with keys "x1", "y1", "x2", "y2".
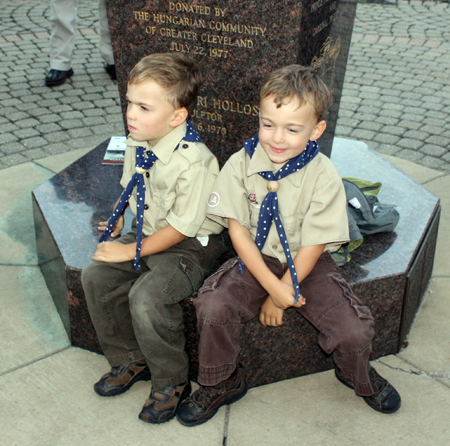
[{"x1": 177, "y1": 368, "x2": 247, "y2": 426}]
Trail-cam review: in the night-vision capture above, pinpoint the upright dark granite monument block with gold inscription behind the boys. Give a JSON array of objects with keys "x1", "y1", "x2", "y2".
[{"x1": 107, "y1": 0, "x2": 356, "y2": 160}]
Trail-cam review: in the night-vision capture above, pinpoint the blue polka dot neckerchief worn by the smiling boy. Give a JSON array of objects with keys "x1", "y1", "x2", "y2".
[{"x1": 239, "y1": 136, "x2": 319, "y2": 303}]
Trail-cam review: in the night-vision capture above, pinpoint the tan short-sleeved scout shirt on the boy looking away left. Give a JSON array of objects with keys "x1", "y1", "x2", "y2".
[{"x1": 120, "y1": 123, "x2": 222, "y2": 237}]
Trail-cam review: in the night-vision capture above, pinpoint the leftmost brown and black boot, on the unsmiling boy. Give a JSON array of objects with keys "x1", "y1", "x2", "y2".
[{"x1": 94, "y1": 359, "x2": 151, "y2": 396}]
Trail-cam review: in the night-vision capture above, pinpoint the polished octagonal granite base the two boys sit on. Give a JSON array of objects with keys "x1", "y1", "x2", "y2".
[{"x1": 33, "y1": 138, "x2": 440, "y2": 387}]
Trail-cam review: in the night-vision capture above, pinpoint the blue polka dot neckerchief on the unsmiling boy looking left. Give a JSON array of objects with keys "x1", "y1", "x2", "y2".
[{"x1": 99, "y1": 121, "x2": 203, "y2": 271}]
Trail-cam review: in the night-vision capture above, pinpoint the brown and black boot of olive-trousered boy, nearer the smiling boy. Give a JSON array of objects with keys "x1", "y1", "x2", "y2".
[{"x1": 139, "y1": 381, "x2": 191, "y2": 424}]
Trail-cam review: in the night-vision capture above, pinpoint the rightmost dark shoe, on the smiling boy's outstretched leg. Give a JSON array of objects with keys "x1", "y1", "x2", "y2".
[{"x1": 335, "y1": 367, "x2": 402, "y2": 413}]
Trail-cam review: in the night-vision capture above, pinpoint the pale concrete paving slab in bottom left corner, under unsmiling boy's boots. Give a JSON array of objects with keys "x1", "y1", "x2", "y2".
[{"x1": 0, "y1": 348, "x2": 224, "y2": 446}]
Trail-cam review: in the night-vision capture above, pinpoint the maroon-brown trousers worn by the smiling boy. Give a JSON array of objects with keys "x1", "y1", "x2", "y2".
[{"x1": 195, "y1": 253, "x2": 375, "y2": 396}]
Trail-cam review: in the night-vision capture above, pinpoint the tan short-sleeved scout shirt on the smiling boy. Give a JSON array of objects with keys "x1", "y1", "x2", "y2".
[{"x1": 208, "y1": 144, "x2": 349, "y2": 263}]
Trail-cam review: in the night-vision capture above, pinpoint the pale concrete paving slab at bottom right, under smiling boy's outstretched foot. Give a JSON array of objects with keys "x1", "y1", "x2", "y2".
[{"x1": 227, "y1": 361, "x2": 450, "y2": 446}]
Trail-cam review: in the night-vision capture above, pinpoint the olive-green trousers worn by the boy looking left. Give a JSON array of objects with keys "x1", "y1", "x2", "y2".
[{"x1": 82, "y1": 232, "x2": 225, "y2": 389}]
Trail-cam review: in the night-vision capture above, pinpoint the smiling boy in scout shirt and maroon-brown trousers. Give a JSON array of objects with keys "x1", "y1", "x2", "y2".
[{"x1": 177, "y1": 65, "x2": 401, "y2": 426}]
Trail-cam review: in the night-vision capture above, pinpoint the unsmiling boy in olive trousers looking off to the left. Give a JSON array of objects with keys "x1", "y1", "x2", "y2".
[{"x1": 82, "y1": 53, "x2": 225, "y2": 423}]
